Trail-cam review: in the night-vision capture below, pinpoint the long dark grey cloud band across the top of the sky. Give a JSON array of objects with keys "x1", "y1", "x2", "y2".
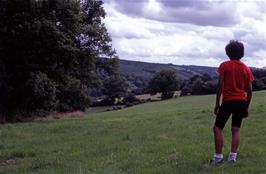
[{"x1": 105, "y1": 0, "x2": 237, "y2": 26}]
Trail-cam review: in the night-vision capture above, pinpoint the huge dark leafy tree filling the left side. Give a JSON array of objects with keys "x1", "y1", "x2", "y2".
[{"x1": 0, "y1": 0, "x2": 116, "y2": 121}]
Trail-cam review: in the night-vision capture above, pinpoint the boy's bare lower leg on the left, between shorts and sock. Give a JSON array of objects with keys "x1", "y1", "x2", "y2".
[{"x1": 213, "y1": 126, "x2": 224, "y2": 154}]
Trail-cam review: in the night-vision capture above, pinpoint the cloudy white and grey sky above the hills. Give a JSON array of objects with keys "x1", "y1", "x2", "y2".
[{"x1": 103, "y1": 0, "x2": 266, "y2": 67}]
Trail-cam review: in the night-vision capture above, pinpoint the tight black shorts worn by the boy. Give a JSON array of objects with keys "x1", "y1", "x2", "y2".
[{"x1": 215, "y1": 100, "x2": 247, "y2": 129}]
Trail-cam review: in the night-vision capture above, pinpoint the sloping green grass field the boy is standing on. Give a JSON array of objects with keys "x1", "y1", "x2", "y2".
[{"x1": 0, "y1": 91, "x2": 266, "y2": 174}]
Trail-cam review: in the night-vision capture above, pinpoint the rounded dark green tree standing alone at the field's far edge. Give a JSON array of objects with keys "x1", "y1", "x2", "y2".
[{"x1": 148, "y1": 70, "x2": 178, "y2": 99}]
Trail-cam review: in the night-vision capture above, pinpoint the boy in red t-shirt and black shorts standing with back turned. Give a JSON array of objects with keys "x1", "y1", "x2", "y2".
[{"x1": 212, "y1": 40, "x2": 254, "y2": 164}]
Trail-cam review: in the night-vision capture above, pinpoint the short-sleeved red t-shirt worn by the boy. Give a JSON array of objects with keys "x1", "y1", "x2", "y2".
[{"x1": 217, "y1": 60, "x2": 254, "y2": 102}]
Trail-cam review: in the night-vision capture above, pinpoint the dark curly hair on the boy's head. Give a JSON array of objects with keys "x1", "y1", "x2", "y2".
[{"x1": 225, "y1": 40, "x2": 244, "y2": 60}]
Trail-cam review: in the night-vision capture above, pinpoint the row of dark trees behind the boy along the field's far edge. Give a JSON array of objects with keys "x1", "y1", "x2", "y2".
[{"x1": 148, "y1": 68, "x2": 266, "y2": 99}]
